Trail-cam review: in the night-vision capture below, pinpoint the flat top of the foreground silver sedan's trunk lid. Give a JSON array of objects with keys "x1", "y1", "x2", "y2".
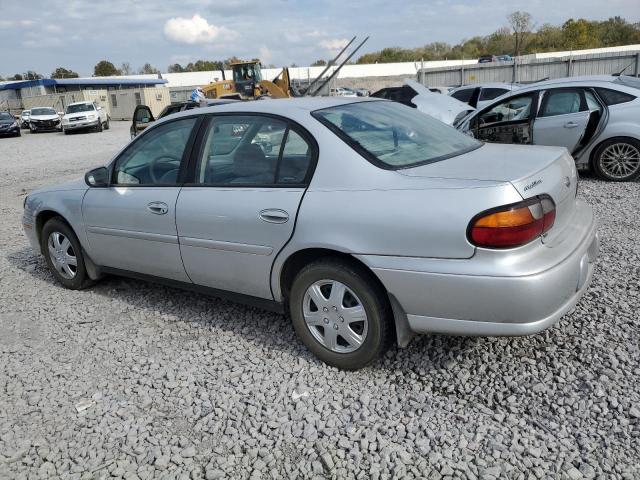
[{"x1": 398, "y1": 143, "x2": 568, "y2": 182}]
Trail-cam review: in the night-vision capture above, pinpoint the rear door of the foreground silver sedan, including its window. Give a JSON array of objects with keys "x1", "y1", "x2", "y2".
[{"x1": 177, "y1": 114, "x2": 317, "y2": 299}]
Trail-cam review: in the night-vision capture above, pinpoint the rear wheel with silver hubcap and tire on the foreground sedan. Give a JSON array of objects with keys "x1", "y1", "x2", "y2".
[{"x1": 289, "y1": 260, "x2": 393, "y2": 370}]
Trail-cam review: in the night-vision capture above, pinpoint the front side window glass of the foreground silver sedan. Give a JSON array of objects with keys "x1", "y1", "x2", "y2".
[{"x1": 112, "y1": 117, "x2": 197, "y2": 186}]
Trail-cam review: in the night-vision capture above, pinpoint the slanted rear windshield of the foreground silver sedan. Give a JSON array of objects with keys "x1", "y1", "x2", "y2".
[{"x1": 313, "y1": 101, "x2": 482, "y2": 169}]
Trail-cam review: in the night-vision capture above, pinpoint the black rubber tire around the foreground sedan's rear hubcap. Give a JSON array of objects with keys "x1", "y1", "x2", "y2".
[{"x1": 289, "y1": 259, "x2": 394, "y2": 370}]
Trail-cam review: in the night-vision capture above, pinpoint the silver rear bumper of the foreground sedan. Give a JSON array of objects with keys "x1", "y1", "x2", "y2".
[{"x1": 360, "y1": 201, "x2": 599, "y2": 336}]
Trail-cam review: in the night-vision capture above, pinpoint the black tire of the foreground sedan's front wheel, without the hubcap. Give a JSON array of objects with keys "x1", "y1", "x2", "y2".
[{"x1": 40, "y1": 217, "x2": 93, "y2": 290}]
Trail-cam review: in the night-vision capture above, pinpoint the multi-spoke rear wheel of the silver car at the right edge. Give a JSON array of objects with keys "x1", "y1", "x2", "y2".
[{"x1": 593, "y1": 138, "x2": 640, "y2": 182}]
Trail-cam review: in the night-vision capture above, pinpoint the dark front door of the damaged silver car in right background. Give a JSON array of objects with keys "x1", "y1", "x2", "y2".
[{"x1": 470, "y1": 92, "x2": 537, "y2": 145}]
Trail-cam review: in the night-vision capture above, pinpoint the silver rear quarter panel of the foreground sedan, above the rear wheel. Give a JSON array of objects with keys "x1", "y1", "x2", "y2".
[{"x1": 271, "y1": 125, "x2": 522, "y2": 300}]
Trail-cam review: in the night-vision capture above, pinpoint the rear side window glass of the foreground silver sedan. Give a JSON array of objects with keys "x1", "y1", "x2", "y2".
[{"x1": 195, "y1": 115, "x2": 312, "y2": 186}]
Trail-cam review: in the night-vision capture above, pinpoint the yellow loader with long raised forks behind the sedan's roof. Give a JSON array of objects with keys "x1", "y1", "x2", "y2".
[{"x1": 202, "y1": 37, "x2": 369, "y2": 100}]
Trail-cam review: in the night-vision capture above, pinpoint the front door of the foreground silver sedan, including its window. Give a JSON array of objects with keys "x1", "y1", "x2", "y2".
[{"x1": 82, "y1": 116, "x2": 198, "y2": 281}]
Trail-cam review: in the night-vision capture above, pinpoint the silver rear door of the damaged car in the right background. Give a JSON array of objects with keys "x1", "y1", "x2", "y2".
[{"x1": 533, "y1": 88, "x2": 591, "y2": 152}]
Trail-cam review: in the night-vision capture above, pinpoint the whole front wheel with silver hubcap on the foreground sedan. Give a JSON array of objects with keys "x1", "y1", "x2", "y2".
[{"x1": 40, "y1": 218, "x2": 93, "y2": 290}]
